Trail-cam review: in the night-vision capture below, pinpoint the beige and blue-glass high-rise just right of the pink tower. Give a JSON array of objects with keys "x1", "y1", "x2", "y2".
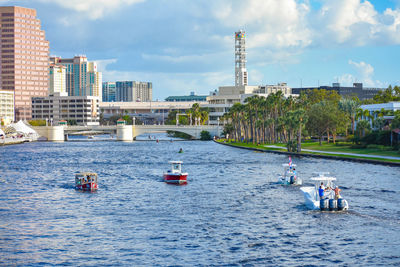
[{"x1": 50, "y1": 56, "x2": 102, "y2": 100}]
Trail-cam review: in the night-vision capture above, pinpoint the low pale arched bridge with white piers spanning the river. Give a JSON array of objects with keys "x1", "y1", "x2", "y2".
[{"x1": 33, "y1": 125, "x2": 223, "y2": 141}]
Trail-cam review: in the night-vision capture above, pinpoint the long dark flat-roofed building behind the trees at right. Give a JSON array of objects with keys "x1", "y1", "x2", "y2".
[{"x1": 292, "y1": 83, "x2": 385, "y2": 100}]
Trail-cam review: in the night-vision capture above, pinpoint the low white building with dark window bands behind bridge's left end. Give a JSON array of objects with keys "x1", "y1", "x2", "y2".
[{"x1": 32, "y1": 93, "x2": 100, "y2": 125}]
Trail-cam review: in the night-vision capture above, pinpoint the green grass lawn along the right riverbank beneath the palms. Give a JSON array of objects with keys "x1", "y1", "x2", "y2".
[{"x1": 217, "y1": 139, "x2": 400, "y2": 163}]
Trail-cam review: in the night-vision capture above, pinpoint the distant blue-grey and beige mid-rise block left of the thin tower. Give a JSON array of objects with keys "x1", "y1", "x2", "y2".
[{"x1": 115, "y1": 81, "x2": 153, "y2": 102}]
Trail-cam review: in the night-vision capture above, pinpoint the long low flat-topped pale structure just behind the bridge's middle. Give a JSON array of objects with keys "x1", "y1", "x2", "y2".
[{"x1": 100, "y1": 101, "x2": 207, "y2": 124}]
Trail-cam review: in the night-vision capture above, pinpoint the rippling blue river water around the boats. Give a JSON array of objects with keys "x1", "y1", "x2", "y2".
[{"x1": 0, "y1": 138, "x2": 400, "y2": 266}]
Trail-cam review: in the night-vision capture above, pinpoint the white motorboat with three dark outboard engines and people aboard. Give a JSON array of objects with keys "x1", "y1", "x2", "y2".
[{"x1": 300, "y1": 173, "x2": 349, "y2": 211}]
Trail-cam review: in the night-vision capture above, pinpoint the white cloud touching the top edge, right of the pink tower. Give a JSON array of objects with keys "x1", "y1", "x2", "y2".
[{"x1": 39, "y1": 0, "x2": 145, "y2": 20}]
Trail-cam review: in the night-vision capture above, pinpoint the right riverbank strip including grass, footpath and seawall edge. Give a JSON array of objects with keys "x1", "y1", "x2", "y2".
[{"x1": 215, "y1": 138, "x2": 400, "y2": 166}]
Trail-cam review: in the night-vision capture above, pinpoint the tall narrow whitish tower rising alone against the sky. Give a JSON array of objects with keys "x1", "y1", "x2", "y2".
[{"x1": 235, "y1": 30, "x2": 247, "y2": 86}]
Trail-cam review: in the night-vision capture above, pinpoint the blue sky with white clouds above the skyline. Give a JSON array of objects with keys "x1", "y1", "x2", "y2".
[{"x1": 0, "y1": 0, "x2": 400, "y2": 100}]
